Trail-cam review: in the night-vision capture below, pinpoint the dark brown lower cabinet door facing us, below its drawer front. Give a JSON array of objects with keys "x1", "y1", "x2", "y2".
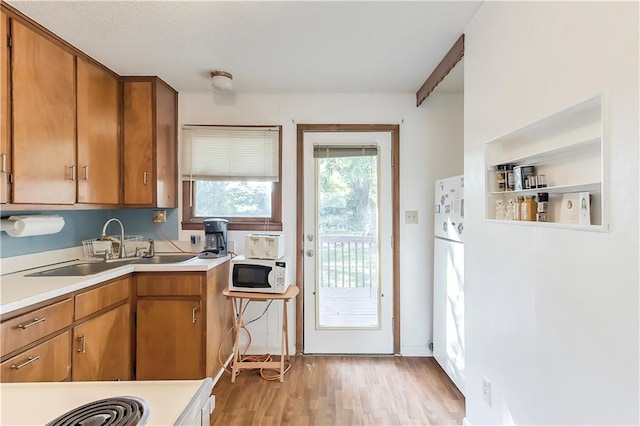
[{"x1": 136, "y1": 299, "x2": 204, "y2": 380}]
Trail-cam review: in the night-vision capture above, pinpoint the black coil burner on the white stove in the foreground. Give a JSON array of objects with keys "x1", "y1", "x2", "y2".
[{"x1": 46, "y1": 396, "x2": 151, "y2": 426}]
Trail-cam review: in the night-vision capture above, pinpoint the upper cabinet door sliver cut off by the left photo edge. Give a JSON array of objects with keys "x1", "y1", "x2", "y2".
[{"x1": 0, "y1": 11, "x2": 11, "y2": 203}]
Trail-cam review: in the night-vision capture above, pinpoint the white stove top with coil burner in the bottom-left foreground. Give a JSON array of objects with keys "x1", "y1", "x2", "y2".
[{"x1": 0, "y1": 378, "x2": 215, "y2": 426}]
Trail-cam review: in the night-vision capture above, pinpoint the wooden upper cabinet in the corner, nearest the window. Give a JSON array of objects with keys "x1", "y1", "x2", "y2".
[{"x1": 123, "y1": 77, "x2": 178, "y2": 208}]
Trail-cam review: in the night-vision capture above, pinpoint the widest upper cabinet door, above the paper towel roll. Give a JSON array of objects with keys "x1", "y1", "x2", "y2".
[{"x1": 11, "y1": 20, "x2": 76, "y2": 204}]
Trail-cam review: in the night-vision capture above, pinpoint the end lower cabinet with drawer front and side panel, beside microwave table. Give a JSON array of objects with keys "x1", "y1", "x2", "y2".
[{"x1": 136, "y1": 262, "x2": 232, "y2": 380}]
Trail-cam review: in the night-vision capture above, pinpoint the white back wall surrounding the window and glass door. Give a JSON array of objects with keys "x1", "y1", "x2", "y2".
[{"x1": 179, "y1": 90, "x2": 462, "y2": 355}]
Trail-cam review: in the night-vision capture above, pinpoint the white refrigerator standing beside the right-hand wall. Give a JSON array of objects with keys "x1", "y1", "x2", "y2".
[{"x1": 433, "y1": 176, "x2": 465, "y2": 394}]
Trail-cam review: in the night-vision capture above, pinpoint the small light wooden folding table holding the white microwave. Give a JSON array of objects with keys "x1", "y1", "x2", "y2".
[{"x1": 222, "y1": 285, "x2": 300, "y2": 383}]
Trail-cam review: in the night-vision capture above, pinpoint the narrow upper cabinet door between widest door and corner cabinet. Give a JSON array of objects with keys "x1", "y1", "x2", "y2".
[{"x1": 77, "y1": 58, "x2": 120, "y2": 204}]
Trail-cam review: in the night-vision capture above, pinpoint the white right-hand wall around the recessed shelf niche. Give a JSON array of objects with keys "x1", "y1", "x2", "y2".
[{"x1": 464, "y1": 2, "x2": 640, "y2": 424}]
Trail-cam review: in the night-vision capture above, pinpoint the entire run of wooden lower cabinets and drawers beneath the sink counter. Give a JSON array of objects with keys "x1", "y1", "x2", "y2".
[{"x1": 0, "y1": 262, "x2": 232, "y2": 382}]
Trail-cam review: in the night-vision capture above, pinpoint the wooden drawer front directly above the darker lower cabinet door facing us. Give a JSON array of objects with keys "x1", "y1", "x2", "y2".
[{"x1": 136, "y1": 274, "x2": 203, "y2": 296}]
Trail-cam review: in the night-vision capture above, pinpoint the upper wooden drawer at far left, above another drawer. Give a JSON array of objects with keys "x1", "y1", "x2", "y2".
[{"x1": 0, "y1": 299, "x2": 73, "y2": 356}]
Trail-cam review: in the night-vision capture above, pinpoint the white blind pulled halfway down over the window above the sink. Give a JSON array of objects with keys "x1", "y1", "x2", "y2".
[{"x1": 182, "y1": 126, "x2": 280, "y2": 182}]
